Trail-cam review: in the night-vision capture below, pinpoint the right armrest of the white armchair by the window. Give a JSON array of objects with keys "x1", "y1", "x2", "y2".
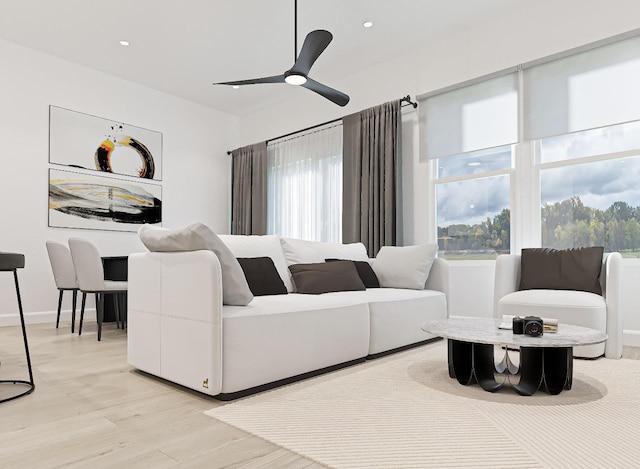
[{"x1": 603, "y1": 252, "x2": 622, "y2": 358}]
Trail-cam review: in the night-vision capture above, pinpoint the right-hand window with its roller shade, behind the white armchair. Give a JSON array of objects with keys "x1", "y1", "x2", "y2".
[{"x1": 523, "y1": 37, "x2": 640, "y2": 257}]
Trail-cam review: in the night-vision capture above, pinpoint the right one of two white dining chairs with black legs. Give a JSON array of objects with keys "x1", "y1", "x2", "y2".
[{"x1": 69, "y1": 238, "x2": 127, "y2": 340}]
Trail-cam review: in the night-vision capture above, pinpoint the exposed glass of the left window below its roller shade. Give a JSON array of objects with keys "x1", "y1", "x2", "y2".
[{"x1": 435, "y1": 147, "x2": 513, "y2": 260}]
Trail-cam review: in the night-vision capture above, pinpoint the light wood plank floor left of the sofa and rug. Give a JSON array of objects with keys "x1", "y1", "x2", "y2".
[{"x1": 0, "y1": 323, "x2": 640, "y2": 469}]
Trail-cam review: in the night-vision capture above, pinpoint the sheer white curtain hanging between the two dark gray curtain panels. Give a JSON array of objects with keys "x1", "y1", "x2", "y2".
[{"x1": 267, "y1": 122, "x2": 342, "y2": 243}]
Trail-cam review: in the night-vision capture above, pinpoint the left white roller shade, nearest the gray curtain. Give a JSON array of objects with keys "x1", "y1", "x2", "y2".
[{"x1": 418, "y1": 73, "x2": 518, "y2": 159}]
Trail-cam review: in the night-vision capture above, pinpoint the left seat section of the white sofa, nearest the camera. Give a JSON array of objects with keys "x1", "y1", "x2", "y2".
[{"x1": 221, "y1": 291, "x2": 369, "y2": 393}]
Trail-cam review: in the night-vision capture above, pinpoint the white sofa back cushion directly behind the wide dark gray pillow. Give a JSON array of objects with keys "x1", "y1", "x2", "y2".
[{"x1": 280, "y1": 238, "x2": 369, "y2": 265}]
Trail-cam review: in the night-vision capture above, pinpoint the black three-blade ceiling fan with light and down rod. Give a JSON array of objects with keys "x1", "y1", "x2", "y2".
[{"x1": 214, "y1": 0, "x2": 349, "y2": 106}]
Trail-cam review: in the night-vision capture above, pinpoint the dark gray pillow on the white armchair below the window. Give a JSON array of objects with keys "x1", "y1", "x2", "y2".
[{"x1": 519, "y1": 246, "x2": 604, "y2": 295}]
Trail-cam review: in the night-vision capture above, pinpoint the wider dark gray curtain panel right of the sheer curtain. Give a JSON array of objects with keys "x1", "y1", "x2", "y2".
[{"x1": 342, "y1": 100, "x2": 402, "y2": 257}]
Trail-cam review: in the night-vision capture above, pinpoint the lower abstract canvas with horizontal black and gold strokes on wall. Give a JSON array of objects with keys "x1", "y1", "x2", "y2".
[{"x1": 49, "y1": 168, "x2": 162, "y2": 232}]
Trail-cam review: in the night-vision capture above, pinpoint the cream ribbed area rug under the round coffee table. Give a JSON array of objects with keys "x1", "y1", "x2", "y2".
[{"x1": 206, "y1": 341, "x2": 640, "y2": 469}]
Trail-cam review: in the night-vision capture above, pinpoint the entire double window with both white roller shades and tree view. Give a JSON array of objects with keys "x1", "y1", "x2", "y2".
[{"x1": 418, "y1": 30, "x2": 640, "y2": 259}]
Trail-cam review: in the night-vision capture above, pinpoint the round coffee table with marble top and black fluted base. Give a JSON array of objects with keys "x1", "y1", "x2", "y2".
[{"x1": 422, "y1": 318, "x2": 607, "y2": 396}]
